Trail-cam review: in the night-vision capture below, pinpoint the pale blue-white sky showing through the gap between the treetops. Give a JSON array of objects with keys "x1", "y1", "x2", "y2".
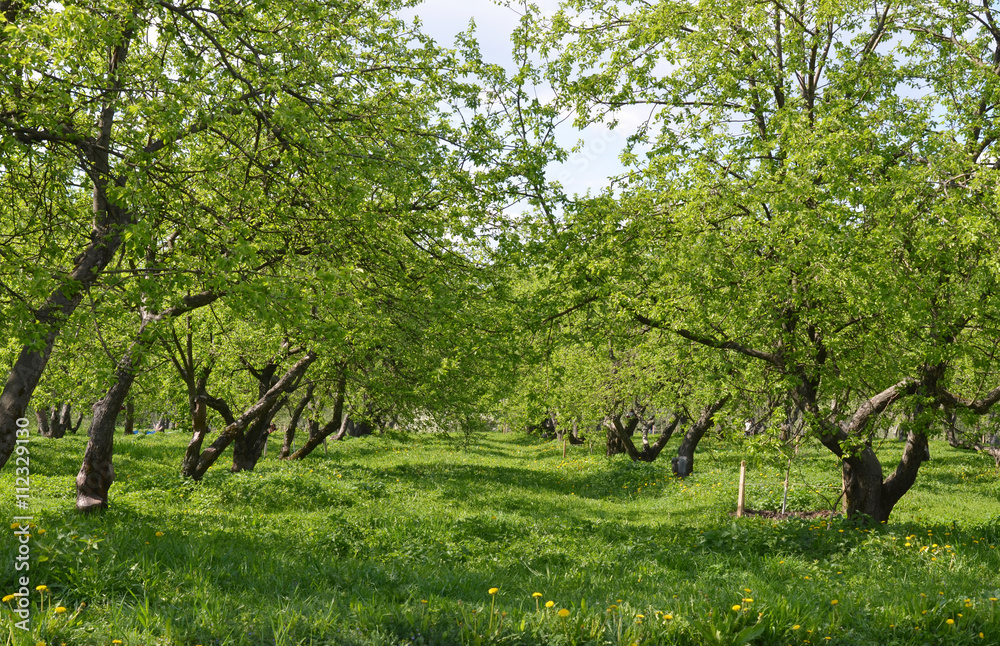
[{"x1": 396, "y1": 0, "x2": 627, "y2": 195}]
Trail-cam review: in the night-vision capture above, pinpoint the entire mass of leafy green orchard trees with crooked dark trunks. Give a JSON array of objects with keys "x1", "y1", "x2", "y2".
[{"x1": 0, "y1": 0, "x2": 1000, "y2": 520}]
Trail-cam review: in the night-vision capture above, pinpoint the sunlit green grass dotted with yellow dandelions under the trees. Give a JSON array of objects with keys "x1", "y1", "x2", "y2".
[{"x1": 0, "y1": 433, "x2": 1000, "y2": 646}]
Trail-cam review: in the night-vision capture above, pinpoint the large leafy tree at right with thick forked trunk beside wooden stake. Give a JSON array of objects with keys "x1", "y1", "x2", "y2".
[{"x1": 522, "y1": 2, "x2": 1000, "y2": 520}]
